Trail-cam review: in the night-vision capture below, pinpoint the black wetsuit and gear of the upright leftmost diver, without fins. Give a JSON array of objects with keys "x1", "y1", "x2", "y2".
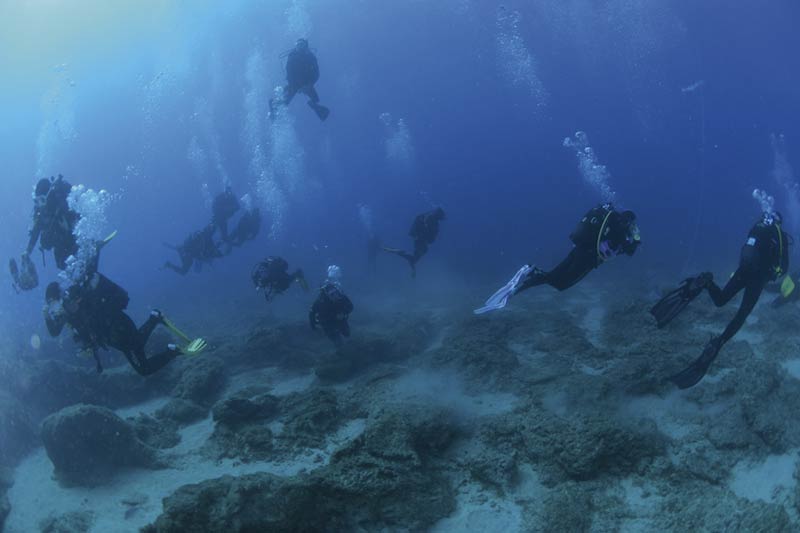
[{"x1": 25, "y1": 175, "x2": 80, "y2": 270}]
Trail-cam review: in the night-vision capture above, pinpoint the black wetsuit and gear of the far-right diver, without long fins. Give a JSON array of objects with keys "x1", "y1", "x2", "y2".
[{"x1": 706, "y1": 222, "x2": 789, "y2": 346}]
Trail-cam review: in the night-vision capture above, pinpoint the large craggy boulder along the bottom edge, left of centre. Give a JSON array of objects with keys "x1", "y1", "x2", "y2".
[{"x1": 148, "y1": 407, "x2": 457, "y2": 533}]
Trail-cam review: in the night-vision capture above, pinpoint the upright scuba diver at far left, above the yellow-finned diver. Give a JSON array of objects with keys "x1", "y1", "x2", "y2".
[{"x1": 8, "y1": 174, "x2": 80, "y2": 291}]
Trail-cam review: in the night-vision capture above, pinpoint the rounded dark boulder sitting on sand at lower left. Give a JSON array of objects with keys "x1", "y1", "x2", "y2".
[{"x1": 42, "y1": 404, "x2": 161, "y2": 486}]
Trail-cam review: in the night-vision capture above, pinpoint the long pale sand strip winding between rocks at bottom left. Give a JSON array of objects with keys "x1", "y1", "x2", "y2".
[{"x1": 5, "y1": 417, "x2": 366, "y2": 533}]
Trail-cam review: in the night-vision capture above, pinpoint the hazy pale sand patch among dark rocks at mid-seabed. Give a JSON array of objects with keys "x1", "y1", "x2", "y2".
[{"x1": 391, "y1": 370, "x2": 518, "y2": 416}]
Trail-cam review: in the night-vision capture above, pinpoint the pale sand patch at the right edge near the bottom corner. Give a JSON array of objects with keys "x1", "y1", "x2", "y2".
[{"x1": 728, "y1": 450, "x2": 798, "y2": 503}]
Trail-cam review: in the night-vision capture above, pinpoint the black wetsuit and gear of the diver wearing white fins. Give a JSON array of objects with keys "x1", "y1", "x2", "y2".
[{"x1": 515, "y1": 204, "x2": 637, "y2": 293}]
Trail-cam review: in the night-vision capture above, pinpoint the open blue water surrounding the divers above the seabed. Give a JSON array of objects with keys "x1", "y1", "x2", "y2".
[{"x1": 0, "y1": 0, "x2": 800, "y2": 528}]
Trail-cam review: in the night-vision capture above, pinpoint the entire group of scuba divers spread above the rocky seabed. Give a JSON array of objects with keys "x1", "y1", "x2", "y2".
[{"x1": 9, "y1": 39, "x2": 800, "y2": 389}]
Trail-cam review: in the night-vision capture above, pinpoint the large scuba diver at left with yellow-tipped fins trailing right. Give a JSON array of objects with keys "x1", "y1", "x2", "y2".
[{"x1": 44, "y1": 272, "x2": 206, "y2": 376}]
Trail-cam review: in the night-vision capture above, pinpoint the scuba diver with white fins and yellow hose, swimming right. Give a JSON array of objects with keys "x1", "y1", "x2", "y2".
[{"x1": 474, "y1": 203, "x2": 641, "y2": 315}]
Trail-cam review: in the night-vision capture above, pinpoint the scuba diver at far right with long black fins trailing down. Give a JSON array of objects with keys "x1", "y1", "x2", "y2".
[{"x1": 650, "y1": 212, "x2": 790, "y2": 389}]
